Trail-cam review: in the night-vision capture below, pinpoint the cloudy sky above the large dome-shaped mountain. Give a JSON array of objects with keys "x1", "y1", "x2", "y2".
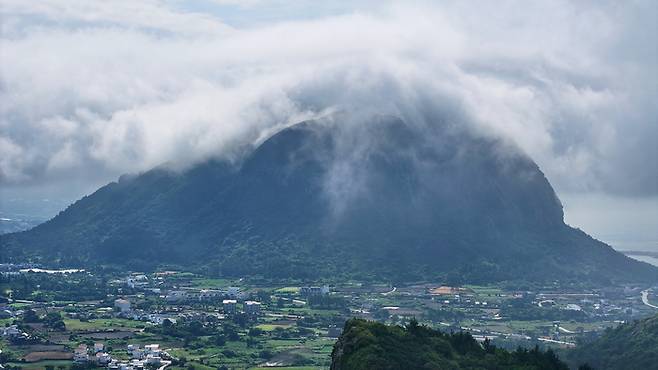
[{"x1": 0, "y1": 0, "x2": 658, "y2": 250}]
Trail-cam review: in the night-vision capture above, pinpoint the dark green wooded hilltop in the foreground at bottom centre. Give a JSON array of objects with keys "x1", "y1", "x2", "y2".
[{"x1": 331, "y1": 319, "x2": 569, "y2": 370}]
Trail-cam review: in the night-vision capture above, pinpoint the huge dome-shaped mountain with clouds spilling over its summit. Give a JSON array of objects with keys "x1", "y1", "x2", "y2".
[{"x1": 0, "y1": 116, "x2": 658, "y2": 282}]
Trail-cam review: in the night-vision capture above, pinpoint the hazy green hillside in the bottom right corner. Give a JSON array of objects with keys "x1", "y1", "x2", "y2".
[{"x1": 565, "y1": 315, "x2": 658, "y2": 370}]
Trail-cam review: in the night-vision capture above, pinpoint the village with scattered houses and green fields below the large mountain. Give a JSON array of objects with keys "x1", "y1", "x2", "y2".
[{"x1": 0, "y1": 266, "x2": 658, "y2": 370}]
